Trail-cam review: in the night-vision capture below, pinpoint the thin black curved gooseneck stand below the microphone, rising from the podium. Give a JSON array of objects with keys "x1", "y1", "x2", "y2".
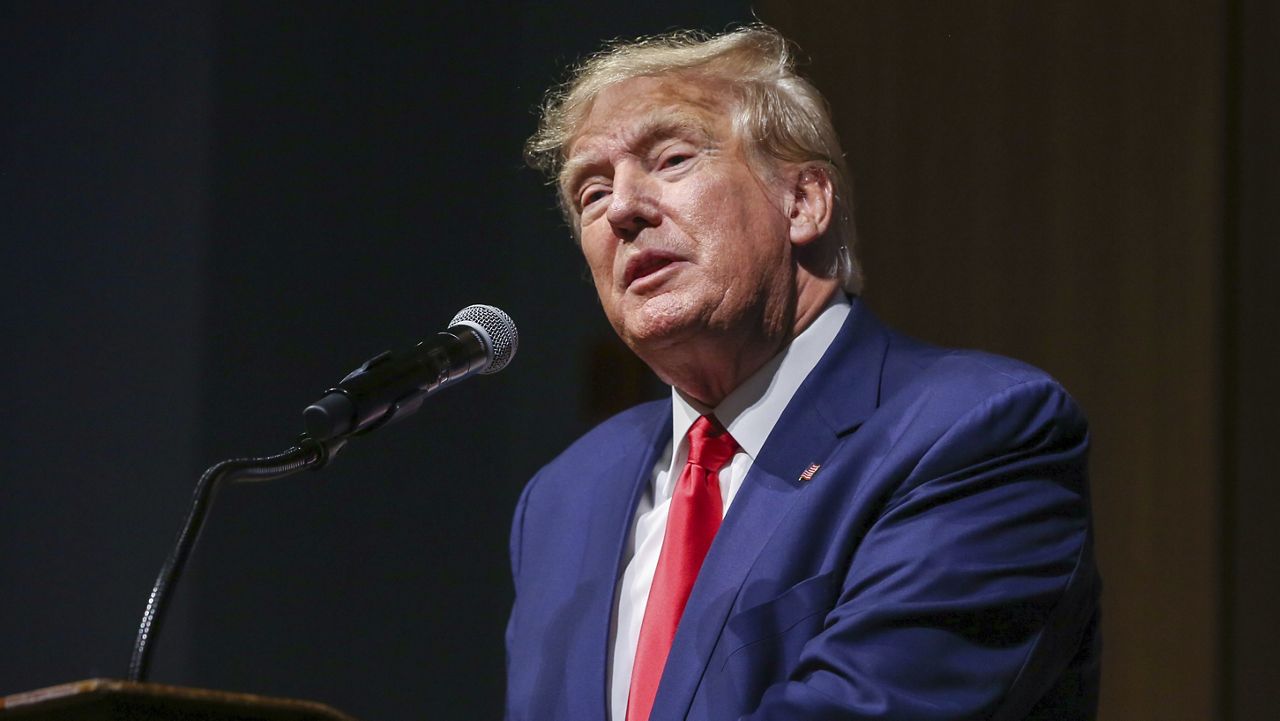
[{"x1": 129, "y1": 435, "x2": 347, "y2": 681}]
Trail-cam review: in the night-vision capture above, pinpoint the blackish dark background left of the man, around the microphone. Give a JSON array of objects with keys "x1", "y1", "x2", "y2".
[{"x1": 0, "y1": 1, "x2": 746, "y2": 720}]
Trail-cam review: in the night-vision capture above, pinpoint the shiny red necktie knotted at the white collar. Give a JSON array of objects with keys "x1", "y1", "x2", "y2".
[{"x1": 626, "y1": 416, "x2": 737, "y2": 721}]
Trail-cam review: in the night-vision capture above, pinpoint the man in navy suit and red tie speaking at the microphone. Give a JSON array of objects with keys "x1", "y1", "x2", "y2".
[{"x1": 507, "y1": 27, "x2": 1100, "y2": 721}]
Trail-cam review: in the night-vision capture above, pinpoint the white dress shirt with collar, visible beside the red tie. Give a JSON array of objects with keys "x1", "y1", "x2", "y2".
[{"x1": 608, "y1": 292, "x2": 850, "y2": 721}]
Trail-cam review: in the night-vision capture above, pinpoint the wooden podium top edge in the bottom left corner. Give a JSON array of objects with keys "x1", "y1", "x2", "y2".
[{"x1": 0, "y1": 679, "x2": 357, "y2": 721}]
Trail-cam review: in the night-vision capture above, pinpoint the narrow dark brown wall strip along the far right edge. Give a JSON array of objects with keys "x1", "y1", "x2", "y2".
[{"x1": 1222, "y1": 0, "x2": 1280, "y2": 721}]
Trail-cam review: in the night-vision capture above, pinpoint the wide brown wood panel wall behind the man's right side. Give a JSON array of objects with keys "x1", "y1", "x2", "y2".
[{"x1": 759, "y1": 0, "x2": 1226, "y2": 721}]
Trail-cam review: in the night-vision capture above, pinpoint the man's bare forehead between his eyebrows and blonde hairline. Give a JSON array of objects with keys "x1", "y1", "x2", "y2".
[{"x1": 561, "y1": 76, "x2": 732, "y2": 178}]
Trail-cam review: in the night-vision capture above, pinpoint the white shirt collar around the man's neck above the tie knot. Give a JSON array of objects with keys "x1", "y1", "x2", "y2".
[{"x1": 671, "y1": 292, "x2": 851, "y2": 461}]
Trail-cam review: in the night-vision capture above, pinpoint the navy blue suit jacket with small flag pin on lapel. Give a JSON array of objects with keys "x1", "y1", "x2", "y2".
[{"x1": 507, "y1": 300, "x2": 1100, "y2": 721}]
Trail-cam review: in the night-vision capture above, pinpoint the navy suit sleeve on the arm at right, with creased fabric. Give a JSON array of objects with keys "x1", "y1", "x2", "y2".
[{"x1": 744, "y1": 380, "x2": 1097, "y2": 721}]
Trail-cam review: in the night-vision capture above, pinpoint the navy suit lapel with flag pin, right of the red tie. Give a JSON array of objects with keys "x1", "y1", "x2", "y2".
[{"x1": 650, "y1": 298, "x2": 888, "y2": 721}]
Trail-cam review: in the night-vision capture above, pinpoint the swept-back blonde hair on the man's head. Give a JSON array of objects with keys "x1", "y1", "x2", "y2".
[{"x1": 525, "y1": 24, "x2": 863, "y2": 295}]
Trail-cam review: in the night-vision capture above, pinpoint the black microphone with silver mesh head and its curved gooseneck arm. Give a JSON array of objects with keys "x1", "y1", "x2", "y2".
[{"x1": 128, "y1": 305, "x2": 520, "y2": 681}]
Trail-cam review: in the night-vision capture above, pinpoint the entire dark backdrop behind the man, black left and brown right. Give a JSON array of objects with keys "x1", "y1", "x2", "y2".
[{"x1": 0, "y1": 0, "x2": 1280, "y2": 721}]
